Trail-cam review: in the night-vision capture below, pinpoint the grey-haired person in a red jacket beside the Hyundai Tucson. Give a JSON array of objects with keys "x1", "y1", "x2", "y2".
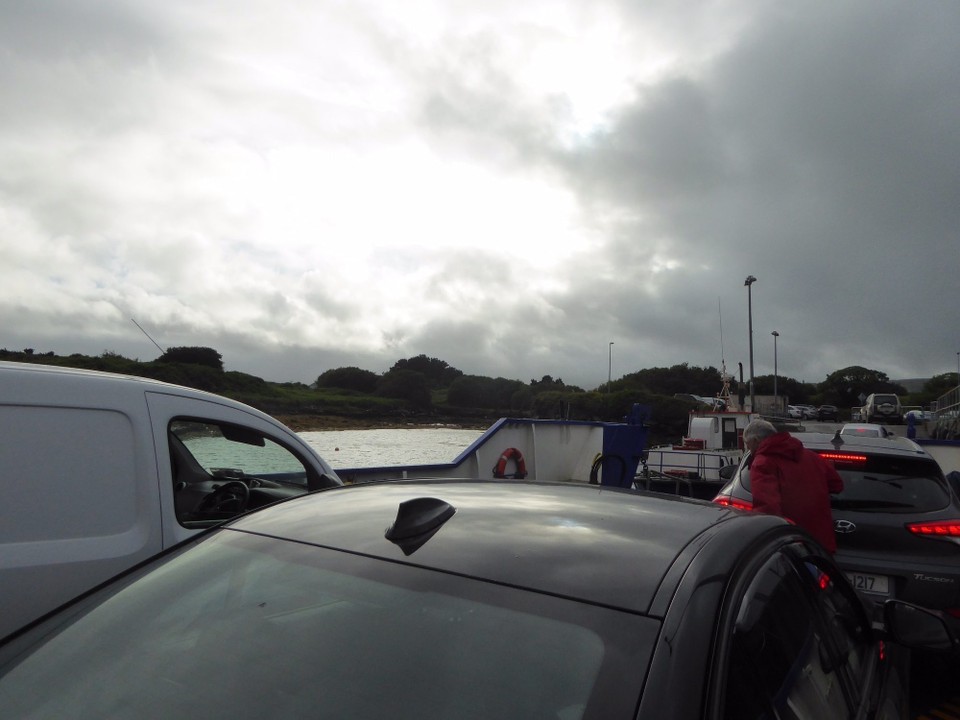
[{"x1": 743, "y1": 420, "x2": 843, "y2": 553}]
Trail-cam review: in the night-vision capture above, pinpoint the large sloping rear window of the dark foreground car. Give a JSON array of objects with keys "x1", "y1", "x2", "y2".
[{"x1": 0, "y1": 531, "x2": 659, "y2": 719}]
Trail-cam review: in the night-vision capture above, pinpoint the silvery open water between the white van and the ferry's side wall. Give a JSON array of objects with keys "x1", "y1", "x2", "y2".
[{"x1": 298, "y1": 427, "x2": 483, "y2": 470}]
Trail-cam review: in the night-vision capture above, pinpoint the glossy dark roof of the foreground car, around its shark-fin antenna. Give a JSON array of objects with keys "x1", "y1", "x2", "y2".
[{"x1": 227, "y1": 480, "x2": 795, "y2": 613}]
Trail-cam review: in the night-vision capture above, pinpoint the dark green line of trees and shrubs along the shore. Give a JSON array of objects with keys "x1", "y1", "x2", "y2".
[{"x1": 0, "y1": 347, "x2": 955, "y2": 438}]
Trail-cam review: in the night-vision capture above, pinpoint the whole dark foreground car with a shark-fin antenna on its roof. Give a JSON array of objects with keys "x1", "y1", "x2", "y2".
[{"x1": 0, "y1": 481, "x2": 955, "y2": 720}]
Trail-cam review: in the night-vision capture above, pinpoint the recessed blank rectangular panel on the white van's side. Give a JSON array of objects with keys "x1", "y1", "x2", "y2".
[{"x1": 0, "y1": 405, "x2": 139, "y2": 542}]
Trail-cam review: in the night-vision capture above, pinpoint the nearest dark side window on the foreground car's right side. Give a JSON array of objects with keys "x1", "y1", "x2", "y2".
[{"x1": 724, "y1": 553, "x2": 862, "y2": 720}]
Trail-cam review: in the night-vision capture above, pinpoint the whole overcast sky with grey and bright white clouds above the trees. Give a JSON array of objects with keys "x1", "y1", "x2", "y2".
[{"x1": 0, "y1": 0, "x2": 960, "y2": 390}]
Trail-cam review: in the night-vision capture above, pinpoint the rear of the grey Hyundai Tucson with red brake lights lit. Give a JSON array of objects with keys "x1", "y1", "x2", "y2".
[{"x1": 714, "y1": 433, "x2": 960, "y2": 617}]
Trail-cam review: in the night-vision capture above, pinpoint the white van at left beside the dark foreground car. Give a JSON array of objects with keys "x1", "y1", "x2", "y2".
[{"x1": 0, "y1": 362, "x2": 342, "y2": 637}]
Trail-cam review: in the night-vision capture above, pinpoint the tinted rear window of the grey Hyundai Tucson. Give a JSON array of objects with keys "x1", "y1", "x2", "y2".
[{"x1": 740, "y1": 451, "x2": 950, "y2": 513}]
